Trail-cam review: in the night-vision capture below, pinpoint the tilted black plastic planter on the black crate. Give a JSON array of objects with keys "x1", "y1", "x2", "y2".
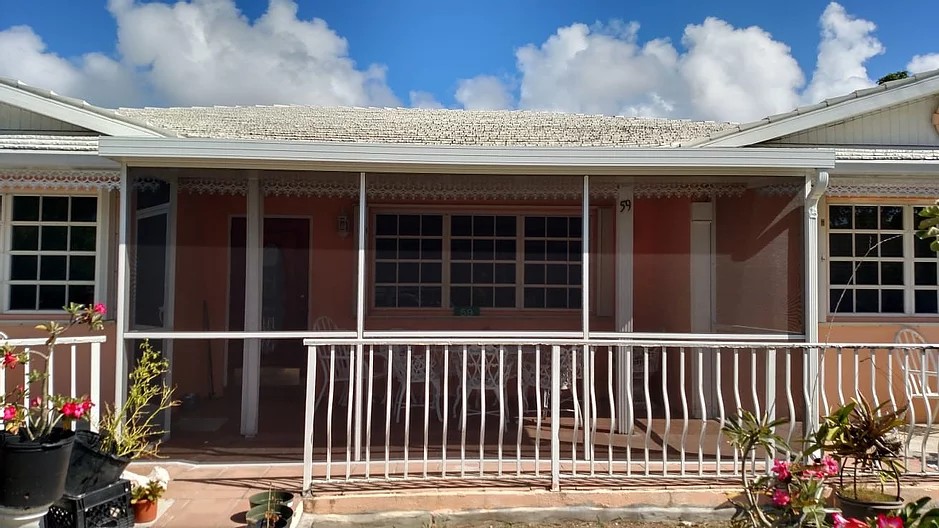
[{"x1": 65, "y1": 431, "x2": 130, "y2": 496}]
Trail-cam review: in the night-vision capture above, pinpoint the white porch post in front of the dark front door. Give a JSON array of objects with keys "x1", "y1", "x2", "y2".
[{"x1": 241, "y1": 171, "x2": 264, "y2": 437}]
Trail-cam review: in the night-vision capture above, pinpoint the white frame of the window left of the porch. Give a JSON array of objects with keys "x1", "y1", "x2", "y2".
[{"x1": 0, "y1": 189, "x2": 110, "y2": 317}]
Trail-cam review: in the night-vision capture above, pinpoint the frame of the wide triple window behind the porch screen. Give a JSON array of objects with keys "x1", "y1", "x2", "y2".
[{"x1": 366, "y1": 205, "x2": 599, "y2": 315}]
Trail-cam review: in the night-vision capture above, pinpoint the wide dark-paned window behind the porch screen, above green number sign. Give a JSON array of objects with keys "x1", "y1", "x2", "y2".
[{"x1": 373, "y1": 213, "x2": 582, "y2": 309}]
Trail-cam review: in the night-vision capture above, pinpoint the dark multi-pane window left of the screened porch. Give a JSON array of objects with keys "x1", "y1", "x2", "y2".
[{"x1": 4, "y1": 195, "x2": 98, "y2": 310}]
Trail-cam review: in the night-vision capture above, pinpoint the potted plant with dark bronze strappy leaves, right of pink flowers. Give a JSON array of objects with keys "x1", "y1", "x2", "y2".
[{"x1": 811, "y1": 397, "x2": 906, "y2": 519}]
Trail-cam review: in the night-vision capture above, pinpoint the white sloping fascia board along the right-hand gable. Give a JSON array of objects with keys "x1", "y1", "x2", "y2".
[{"x1": 693, "y1": 76, "x2": 939, "y2": 147}]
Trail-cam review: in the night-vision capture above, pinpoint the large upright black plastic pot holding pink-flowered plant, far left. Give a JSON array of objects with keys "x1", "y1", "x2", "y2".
[{"x1": 0, "y1": 429, "x2": 75, "y2": 509}]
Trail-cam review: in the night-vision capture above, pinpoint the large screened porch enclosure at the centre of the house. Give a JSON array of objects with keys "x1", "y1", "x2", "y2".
[{"x1": 122, "y1": 168, "x2": 805, "y2": 454}]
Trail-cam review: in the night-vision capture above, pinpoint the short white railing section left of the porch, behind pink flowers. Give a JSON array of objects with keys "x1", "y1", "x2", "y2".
[{"x1": 0, "y1": 334, "x2": 109, "y2": 430}]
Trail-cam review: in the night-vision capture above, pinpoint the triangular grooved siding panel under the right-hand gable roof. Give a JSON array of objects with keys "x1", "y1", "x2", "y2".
[{"x1": 768, "y1": 96, "x2": 939, "y2": 147}]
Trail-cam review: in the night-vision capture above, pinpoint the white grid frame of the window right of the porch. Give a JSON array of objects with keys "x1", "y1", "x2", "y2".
[{"x1": 821, "y1": 199, "x2": 939, "y2": 320}]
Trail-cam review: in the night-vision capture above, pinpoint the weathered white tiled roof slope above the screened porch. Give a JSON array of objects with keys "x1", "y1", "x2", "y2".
[{"x1": 118, "y1": 105, "x2": 733, "y2": 147}]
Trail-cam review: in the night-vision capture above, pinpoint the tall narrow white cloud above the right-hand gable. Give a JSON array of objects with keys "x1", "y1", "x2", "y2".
[{"x1": 803, "y1": 2, "x2": 884, "y2": 103}]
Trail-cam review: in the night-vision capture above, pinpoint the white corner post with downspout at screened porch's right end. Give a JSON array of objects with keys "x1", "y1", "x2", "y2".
[{"x1": 802, "y1": 171, "x2": 828, "y2": 435}]
